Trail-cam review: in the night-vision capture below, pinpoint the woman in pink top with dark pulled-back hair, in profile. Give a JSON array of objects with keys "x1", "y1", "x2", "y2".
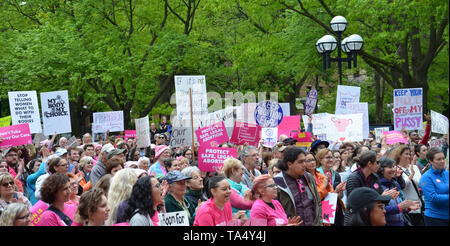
[{"x1": 194, "y1": 176, "x2": 247, "y2": 226}]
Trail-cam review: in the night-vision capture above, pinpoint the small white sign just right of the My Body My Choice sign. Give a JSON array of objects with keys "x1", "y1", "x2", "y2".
[{"x1": 92, "y1": 111, "x2": 124, "y2": 133}]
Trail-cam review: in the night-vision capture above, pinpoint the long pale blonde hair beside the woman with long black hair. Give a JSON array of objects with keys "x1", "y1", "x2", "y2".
[{"x1": 105, "y1": 168, "x2": 137, "y2": 225}]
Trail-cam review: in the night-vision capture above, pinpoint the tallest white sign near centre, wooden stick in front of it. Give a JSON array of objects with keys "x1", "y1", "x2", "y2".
[{"x1": 174, "y1": 75, "x2": 208, "y2": 128}]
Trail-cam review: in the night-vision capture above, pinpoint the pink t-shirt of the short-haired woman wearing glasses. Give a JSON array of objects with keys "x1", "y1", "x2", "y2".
[{"x1": 250, "y1": 199, "x2": 288, "y2": 226}]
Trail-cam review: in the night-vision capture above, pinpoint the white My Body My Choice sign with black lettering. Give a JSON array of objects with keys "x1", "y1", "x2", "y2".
[{"x1": 41, "y1": 90, "x2": 72, "y2": 136}]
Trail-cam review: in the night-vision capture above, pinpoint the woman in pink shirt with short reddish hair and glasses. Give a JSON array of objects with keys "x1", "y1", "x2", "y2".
[{"x1": 250, "y1": 174, "x2": 303, "y2": 226}]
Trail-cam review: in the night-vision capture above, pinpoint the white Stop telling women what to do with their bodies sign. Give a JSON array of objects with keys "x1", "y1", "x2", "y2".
[{"x1": 8, "y1": 91, "x2": 41, "y2": 134}]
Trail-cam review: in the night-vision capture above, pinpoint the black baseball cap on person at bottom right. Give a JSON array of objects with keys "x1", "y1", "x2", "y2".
[{"x1": 347, "y1": 187, "x2": 391, "y2": 210}]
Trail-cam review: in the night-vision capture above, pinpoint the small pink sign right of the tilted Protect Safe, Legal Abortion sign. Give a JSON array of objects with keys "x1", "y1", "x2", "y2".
[{"x1": 230, "y1": 121, "x2": 262, "y2": 147}]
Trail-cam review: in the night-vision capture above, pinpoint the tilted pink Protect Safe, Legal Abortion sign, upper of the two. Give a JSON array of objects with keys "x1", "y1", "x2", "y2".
[{"x1": 195, "y1": 121, "x2": 229, "y2": 147}]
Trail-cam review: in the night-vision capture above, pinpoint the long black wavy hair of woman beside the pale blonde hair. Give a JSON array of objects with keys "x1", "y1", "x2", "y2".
[{"x1": 125, "y1": 176, "x2": 156, "y2": 220}]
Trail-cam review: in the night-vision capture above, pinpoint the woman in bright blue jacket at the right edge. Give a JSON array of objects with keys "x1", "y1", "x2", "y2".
[{"x1": 420, "y1": 147, "x2": 449, "y2": 226}]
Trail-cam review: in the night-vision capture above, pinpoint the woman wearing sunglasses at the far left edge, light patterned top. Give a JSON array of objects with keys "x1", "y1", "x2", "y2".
[{"x1": 0, "y1": 173, "x2": 32, "y2": 210}]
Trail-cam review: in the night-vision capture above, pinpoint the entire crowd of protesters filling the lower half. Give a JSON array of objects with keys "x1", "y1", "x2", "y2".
[{"x1": 0, "y1": 112, "x2": 449, "y2": 226}]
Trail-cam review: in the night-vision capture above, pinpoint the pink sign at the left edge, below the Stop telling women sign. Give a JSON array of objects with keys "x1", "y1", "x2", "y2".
[{"x1": 0, "y1": 124, "x2": 33, "y2": 148}]
